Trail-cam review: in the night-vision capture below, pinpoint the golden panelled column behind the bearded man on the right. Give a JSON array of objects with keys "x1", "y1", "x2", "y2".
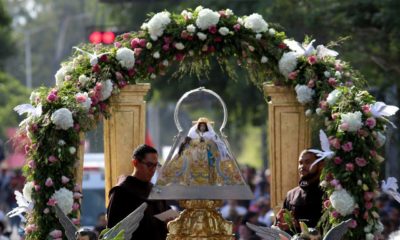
[{"x1": 263, "y1": 83, "x2": 311, "y2": 211}]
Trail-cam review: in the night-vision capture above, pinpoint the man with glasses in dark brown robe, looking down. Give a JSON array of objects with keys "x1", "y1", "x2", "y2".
[{"x1": 107, "y1": 145, "x2": 168, "y2": 240}]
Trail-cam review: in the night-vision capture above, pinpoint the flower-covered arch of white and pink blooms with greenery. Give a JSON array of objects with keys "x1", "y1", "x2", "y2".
[{"x1": 19, "y1": 7, "x2": 388, "y2": 240}]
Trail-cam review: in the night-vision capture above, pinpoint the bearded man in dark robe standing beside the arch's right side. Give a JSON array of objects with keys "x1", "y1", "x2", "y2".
[{"x1": 276, "y1": 150, "x2": 323, "y2": 231}]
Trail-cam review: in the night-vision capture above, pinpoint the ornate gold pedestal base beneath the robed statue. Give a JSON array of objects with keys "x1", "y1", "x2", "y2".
[{"x1": 167, "y1": 200, "x2": 234, "y2": 240}]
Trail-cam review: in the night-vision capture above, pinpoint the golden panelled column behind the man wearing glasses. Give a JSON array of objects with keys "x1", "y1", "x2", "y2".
[{"x1": 104, "y1": 84, "x2": 150, "y2": 205}]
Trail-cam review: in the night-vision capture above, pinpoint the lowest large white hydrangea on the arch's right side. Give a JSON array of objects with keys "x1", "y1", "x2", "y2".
[{"x1": 329, "y1": 189, "x2": 355, "y2": 216}]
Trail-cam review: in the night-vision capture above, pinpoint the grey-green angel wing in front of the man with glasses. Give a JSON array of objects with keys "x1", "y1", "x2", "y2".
[{"x1": 102, "y1": 203, "x2": 147, "y2": 240}]
